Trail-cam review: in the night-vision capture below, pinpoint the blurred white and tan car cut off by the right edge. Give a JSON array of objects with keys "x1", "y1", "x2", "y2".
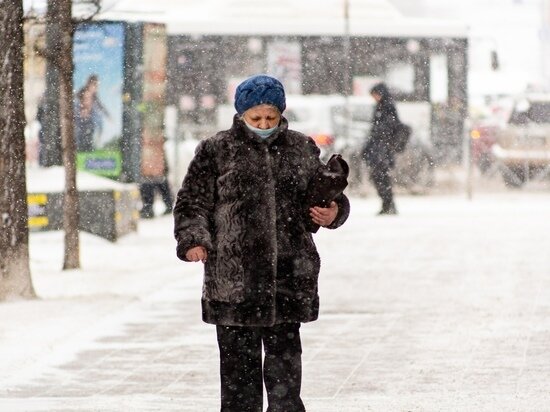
[{"x1": 492, "y1": 94, "x2": 550, "y2": 187}]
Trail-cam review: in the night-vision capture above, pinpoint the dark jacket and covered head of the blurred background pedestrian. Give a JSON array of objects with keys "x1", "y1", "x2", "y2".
[{"x1": 364, "y1": 85, "x2": 399, "y2": 167}]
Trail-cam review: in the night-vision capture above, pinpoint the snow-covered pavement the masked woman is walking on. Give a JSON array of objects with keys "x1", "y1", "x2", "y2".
[{"x1": 0, "y1": 192, "x2": 550, "y2": 412}]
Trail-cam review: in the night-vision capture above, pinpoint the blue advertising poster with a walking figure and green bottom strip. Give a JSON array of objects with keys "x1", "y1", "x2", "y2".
[{"x1": 73, "y1": 22, "x2": 125, "y2": 178}]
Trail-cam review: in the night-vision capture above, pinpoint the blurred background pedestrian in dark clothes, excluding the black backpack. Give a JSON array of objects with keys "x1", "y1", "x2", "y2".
[{"x1": 364, "y1": 83, "x2": 399, "y2": 215}]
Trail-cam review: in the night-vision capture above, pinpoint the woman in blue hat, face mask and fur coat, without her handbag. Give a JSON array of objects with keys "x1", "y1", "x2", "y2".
[{"x1": 174, "y1": 75, "x2": 349, "y2": 412}]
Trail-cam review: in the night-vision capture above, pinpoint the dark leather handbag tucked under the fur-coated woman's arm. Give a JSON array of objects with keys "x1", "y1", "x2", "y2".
[{"x1": 306, "y1": 154, "x2": 349, "y2": 209}]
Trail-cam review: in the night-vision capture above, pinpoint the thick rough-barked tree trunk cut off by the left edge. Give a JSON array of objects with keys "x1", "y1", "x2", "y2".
[{"x1": 0, "y1": 0, "x2": 36, "y2": 300}]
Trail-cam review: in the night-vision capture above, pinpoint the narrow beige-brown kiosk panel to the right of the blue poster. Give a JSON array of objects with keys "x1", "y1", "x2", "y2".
[{"x1": 139, "y1": 24, "x2": 168, "y2": 178}]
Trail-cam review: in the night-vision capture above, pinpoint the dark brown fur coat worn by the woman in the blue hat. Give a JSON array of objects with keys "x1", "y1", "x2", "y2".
[{"x1": 174, "y1": 116, "x2": 349, "y2": 326}]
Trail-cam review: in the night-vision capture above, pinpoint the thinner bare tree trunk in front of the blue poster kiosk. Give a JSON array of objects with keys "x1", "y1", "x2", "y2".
[{"x1": 47, "y1": 0, "x2": 80, "y2": 269}]
